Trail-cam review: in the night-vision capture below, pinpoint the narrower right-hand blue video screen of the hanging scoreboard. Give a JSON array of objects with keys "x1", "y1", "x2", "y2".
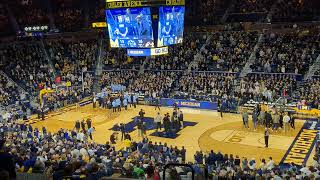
[{"x1": 157, "y1": 6, "x2": 185, "y2": 47}]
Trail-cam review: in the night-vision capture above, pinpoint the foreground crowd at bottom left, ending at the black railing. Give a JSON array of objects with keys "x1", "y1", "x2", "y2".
[{"x1": 0, "y1": 123, "x2": 194, "y2": 180}]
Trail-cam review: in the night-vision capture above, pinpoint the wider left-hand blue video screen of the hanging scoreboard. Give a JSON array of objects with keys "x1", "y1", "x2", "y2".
[{"x1": 106, "y1": 7, "x2": 154, "y2": 48}]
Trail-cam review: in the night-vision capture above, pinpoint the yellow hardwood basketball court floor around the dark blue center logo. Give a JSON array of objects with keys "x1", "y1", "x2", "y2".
[{"x1": 21, "y1": 104, "x2": 313, "y2": 164}]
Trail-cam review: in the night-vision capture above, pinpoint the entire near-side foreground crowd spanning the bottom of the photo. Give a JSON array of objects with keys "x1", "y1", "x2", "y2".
[{"x1": 0, "y1": 119, "x2": 319, "y2": 180}]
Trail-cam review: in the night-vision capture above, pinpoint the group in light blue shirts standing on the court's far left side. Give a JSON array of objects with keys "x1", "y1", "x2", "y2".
[{"x1": 93, "y1": 92, "x2": 138, "y2": 112}]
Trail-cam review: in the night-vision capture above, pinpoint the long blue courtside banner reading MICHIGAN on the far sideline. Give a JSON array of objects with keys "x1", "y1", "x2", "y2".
[{"x1": 160, "y1": 98, "x2": 218, "y2": 110}]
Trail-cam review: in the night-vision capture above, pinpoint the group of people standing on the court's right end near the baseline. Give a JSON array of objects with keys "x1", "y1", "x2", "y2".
[{"x1": 242, "y1": 105, "x2": 295, "y2": 132}]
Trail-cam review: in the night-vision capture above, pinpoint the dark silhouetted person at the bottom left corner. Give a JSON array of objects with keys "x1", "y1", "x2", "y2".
[{"x1": 0, "y1": 139, "x2": 17, "y2": 179}]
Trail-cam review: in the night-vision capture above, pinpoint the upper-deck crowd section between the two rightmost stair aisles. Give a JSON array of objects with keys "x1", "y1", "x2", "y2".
[{"x1": 251, "y1": 33, "x2": 319, "y2": 74}]
